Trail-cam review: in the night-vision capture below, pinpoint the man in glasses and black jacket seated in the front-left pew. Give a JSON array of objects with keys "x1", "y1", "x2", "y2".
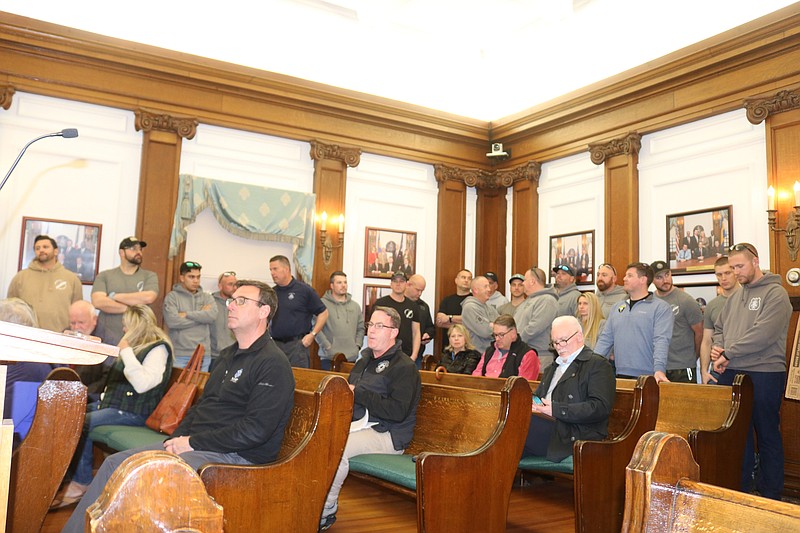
[{"x1": 63, "y1": 280, "x2": 294, "y2": 533}]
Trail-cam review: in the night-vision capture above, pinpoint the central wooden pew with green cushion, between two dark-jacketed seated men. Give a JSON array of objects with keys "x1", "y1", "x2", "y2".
[{"x1": 350, "y1": 377, "x2": 531, "y2": 533}]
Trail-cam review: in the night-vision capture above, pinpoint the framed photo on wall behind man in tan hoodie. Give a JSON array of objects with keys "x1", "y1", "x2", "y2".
[{"x1": 18, "y1": 217, "x2": 103, "y2": 285}]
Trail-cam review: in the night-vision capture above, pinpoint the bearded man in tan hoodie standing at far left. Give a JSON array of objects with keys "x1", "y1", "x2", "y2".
[{"x1": 8, "y1": 235, "x2": 83, "y2": 333}]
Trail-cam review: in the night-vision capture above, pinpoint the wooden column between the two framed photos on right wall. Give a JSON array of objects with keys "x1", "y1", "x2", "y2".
[{"x1": 589, "y1": 133, "x2": 642, "y2": 272}]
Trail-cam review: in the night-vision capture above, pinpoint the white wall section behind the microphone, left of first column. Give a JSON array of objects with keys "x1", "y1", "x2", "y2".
[{"x1": 0, "y1": 93, "x2": 142, "y2": 300}]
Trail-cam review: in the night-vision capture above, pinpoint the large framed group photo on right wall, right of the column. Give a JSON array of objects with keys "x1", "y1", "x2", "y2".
[{"x1": 666, "y1": 205, "x2": 733, "y2": 275}]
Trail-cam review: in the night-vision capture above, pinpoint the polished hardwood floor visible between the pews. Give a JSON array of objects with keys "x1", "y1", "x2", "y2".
[{"x1": 42, "y1": 478, "x2": 575, "y2": 533}]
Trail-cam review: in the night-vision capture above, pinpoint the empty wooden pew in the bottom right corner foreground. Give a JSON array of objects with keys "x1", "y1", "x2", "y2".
[{"x1": 622, "y1": 431, "x2": 800, "y2": 533}]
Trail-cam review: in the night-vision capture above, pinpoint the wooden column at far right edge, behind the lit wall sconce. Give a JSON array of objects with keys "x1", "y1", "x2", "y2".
[{"x1": 745, "y1": 90, "x2": 800, "y2": 498}]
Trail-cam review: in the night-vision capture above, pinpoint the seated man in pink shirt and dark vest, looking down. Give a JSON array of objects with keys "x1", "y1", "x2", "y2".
[{"x1": 472, "y1": 315, "x2": 539, "y2": 380}]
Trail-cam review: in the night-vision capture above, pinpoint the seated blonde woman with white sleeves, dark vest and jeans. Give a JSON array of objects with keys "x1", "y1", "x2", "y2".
[{"x1": 52, "y1": 305, "x2": 173, "y2": 507}]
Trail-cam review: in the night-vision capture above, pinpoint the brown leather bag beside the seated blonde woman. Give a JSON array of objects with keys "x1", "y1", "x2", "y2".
[{"x1": 145, "y1": 344, "x2": 206, "y2": 435}]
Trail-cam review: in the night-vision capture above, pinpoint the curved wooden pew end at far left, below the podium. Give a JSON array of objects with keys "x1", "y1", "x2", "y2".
[{"x1": 8, "y1": 368, "x2": 86, "y2": 533}]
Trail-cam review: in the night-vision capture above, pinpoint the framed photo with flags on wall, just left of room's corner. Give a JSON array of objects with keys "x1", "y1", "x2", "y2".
[{"x1": 364, "y1": 228, "x2": 417, "y2": 279}]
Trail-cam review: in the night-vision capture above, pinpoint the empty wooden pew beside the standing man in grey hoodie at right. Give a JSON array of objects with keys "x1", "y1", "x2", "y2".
[{"x1": 655, "y1": 374, "x2": 753, "y2": 489}]
